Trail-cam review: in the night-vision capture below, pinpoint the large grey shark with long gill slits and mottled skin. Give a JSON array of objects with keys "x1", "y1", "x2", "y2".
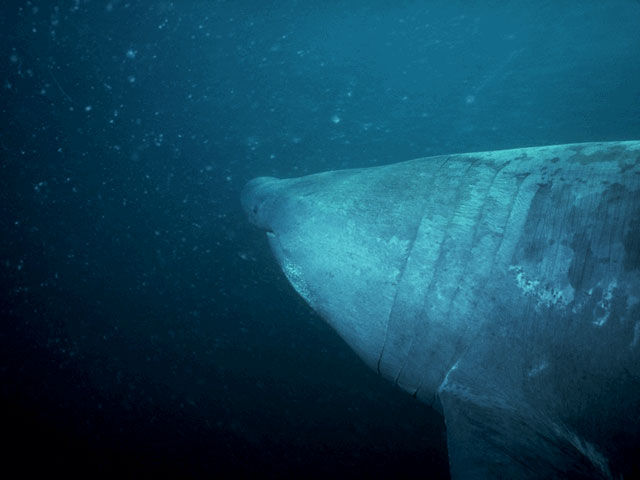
[{"x1": 242, "y1": 142, "x2": 640, "y2": 479}]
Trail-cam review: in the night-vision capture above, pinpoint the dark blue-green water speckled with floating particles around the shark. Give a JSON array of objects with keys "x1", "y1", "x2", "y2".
[{"x1": 0, "y1": 0, "x2": 640, "y2": 478}]
